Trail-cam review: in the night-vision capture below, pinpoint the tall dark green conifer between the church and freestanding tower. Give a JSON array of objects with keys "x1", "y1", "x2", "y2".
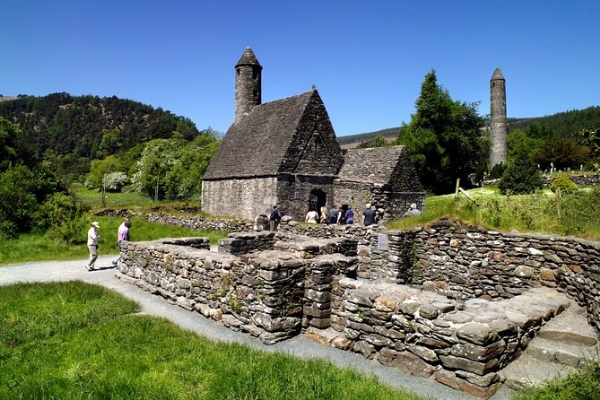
[{"x1": 398, "y1": 70, "x2": 490, "y2": 194}]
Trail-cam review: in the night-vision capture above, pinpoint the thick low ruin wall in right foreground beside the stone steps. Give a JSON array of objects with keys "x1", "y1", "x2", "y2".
[{"x1": 331, "y1": 278, "x2": 569, "y2": 398}]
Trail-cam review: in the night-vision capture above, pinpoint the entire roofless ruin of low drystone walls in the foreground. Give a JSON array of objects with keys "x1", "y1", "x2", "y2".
[{"x1": 119, "y1": 221, "x2": 600, "y2": 397}]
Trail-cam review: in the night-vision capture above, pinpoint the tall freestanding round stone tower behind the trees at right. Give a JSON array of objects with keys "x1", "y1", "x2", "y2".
[{"x1": 490, "y1": 68, "x2": 508, "y2": 168}]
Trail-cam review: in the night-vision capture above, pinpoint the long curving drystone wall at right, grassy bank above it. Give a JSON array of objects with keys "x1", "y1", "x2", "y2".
[{"x1": 358, "y1": 220, "x2": 600, "y2": 330}]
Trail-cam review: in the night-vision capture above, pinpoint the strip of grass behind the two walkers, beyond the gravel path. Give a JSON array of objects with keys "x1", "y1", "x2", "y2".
[{"x1": 0, "y1": 216, "x2": 227, "y2": 266}]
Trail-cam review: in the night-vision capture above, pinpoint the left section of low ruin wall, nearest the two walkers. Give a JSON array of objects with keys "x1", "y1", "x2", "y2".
[{"x1": 117, "y1": 232, "x2": 358, "y2": 344}]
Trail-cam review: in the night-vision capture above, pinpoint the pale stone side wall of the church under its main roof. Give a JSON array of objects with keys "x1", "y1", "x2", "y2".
[{"x1": 202, "y1": 177, "x2": 277, "y2": 220}]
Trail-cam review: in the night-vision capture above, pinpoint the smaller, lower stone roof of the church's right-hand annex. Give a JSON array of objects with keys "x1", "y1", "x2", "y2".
[{"x1": 339, "y1": 146, "x2": 408, "y2": 184}]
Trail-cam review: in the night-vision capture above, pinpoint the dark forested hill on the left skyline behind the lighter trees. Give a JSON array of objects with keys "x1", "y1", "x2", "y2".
[{"x1": 0, "y1": 93, "x2": 199, "y2": 159}]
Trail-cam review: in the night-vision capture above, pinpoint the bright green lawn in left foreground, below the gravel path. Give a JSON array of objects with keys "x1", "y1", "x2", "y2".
[{"x1": 0, "y1": 282, "x2": 419, "y2": 400}]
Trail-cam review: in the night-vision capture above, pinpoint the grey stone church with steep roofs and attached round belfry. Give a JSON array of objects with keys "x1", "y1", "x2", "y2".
[{"x1": 202, "y1": 47, "x2": 425, "y2": 221}]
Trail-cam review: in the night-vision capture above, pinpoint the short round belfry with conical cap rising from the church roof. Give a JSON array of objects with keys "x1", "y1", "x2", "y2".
[{"x1": 234, "y1": 47, "x2": 262, "y2": 123}]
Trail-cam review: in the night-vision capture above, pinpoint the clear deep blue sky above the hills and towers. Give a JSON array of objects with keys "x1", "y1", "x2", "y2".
[{"x1": 0, "y1": 0, "x2": 600, "y2": 136}]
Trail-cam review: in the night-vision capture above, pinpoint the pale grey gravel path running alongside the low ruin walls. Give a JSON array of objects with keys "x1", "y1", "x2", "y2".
[{"x1": 0, "y1": 256, "x2": 510, "y2": 400}]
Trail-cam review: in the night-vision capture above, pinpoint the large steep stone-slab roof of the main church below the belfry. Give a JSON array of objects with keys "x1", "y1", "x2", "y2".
[{"x1": 203, "y1": 89, "x2": 319, "y2": 180}]
